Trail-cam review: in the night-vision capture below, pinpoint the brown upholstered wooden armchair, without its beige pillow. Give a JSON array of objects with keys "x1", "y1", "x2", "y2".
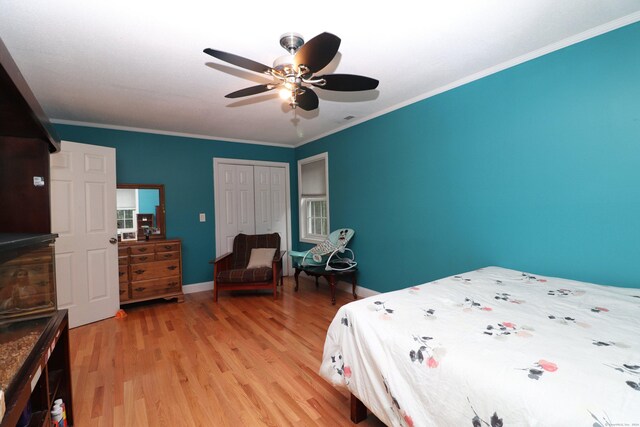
[{"x1": 213, "y1": 233, "x2": 286, "y2": 302}]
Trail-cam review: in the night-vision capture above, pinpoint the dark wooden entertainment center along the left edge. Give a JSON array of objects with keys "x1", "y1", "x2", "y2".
[{"x1": 0, "y1": 36, "x2": 73, "y2": 427}]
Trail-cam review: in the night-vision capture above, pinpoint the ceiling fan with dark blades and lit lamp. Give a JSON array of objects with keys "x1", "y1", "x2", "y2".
[{"x1": 204, "y1": 33, "x2": 378, "y2": 111}]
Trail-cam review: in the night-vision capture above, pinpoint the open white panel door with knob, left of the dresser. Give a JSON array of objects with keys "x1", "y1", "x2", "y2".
[{"x1": 51, "y1": 141, "x2": 120, "y2": 328}]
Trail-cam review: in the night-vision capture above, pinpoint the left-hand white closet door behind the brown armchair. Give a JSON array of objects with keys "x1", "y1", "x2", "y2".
[{"x1": 216, "y1": 164, "x2": 255, "y2": 255}]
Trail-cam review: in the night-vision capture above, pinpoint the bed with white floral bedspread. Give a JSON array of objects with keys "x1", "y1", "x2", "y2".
[{"x1": 320, "y1": 267, "x2": 640, "y2": 427}]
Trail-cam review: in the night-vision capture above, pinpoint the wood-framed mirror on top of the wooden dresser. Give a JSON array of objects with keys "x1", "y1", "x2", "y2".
[{"x1": 116, "y1": 184, "x2": 167, "y2": 242}]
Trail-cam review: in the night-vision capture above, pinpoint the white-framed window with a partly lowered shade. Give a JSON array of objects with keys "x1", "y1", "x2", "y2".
[{"x1": 298, "y1": 153, "x2": 329, "y2": 243}]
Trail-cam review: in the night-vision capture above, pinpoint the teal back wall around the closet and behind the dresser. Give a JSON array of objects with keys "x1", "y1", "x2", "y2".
[{"x1": 55, "y1": 125, "x2": 298, "y2": 285}]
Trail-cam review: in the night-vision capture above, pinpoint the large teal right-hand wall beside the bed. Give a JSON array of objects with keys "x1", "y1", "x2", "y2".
[{"x1": 296, "y1": 24, "x2": 640, "y2": 291}]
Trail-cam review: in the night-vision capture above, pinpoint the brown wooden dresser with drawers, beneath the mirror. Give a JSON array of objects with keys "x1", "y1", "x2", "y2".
[{"x1": 118, "y1": 239, "x2": 184, "y2": 305}]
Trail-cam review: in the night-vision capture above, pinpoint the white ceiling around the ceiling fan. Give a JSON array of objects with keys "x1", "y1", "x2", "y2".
[{"x1": 0, "y1": 0, "x2": 640, "y2": 146}]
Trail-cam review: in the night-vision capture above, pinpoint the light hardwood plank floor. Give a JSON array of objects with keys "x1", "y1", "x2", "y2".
[{"x1": 70, "y1": 278, "x2": 383, "y2": 427}]
